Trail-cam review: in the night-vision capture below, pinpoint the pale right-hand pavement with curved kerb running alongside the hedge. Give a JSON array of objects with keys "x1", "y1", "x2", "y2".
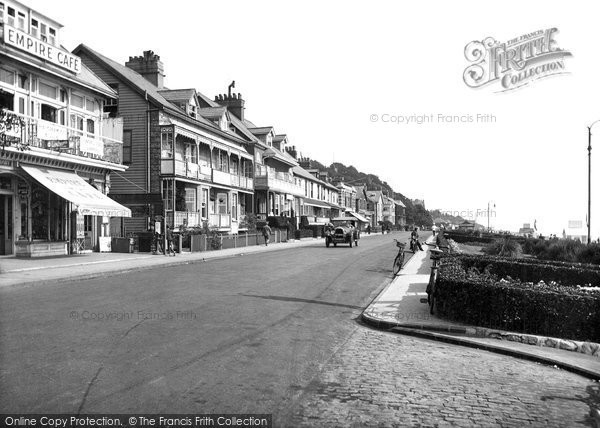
[{"x1": 361, "y1": 238, "x2": 600, "y2": 380}]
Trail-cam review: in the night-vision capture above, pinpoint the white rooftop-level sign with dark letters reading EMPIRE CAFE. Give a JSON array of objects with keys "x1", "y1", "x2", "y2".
[{"x1": 4, "y1": 25, "x2": 81, "y2": 73}]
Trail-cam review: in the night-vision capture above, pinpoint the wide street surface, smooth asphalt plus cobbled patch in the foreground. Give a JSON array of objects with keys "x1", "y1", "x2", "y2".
[{"x1": 0, "y1": 233, "x2": 597, "y2": 426}]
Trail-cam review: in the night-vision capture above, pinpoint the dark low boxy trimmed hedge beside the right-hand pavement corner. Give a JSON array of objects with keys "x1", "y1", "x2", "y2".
[{"x1": 436, "y1": 256, "x2": 600, "y2": 342}]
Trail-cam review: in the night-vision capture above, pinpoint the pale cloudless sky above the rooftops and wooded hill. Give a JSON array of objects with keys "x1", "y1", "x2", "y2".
[{"x1": 24, "y1": 0, "x2": 600, "y2": 238}]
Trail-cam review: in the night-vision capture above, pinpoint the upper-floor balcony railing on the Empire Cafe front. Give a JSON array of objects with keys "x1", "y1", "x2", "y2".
[{"x1": 0, "y1": 112, "x2": 123, "y2": 164}]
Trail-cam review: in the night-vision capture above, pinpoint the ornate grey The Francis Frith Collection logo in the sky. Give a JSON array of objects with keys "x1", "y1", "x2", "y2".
[{"x1": 463, "y1": 28, "x2": 571, "y2": 92}]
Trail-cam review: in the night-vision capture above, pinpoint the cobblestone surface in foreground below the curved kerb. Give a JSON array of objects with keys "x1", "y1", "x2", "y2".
[{"x1": 282, "y1": 327, "x2": 600, "y2": 427}]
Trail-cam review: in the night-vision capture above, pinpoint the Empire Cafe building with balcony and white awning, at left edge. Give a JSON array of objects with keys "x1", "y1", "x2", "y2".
[{"x1": 0, "y1": 0, "x2": 131, "y2": 257}]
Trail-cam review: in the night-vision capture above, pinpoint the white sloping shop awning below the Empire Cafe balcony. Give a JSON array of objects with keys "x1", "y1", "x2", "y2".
[{"x1": 21, "y1": 165, "x2": 131, "y2": 217}]
